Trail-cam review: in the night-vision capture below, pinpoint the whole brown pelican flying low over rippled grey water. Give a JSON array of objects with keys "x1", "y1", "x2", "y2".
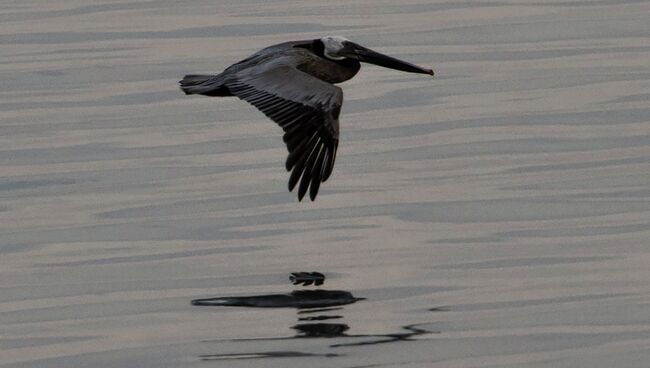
[{"x1": 180, "y1": 36, "x2": 433, "y2": 201}]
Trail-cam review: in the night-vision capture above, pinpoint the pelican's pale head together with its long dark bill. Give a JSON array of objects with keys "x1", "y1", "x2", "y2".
[{"x1": 319, "y1": 36, "x2": 433, "y2": 75}]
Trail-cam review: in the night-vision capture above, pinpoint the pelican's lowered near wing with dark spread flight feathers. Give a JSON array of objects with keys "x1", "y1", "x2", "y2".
[{"x1": 225, "y1": 65, "x2": 343, "y2": 201}]
